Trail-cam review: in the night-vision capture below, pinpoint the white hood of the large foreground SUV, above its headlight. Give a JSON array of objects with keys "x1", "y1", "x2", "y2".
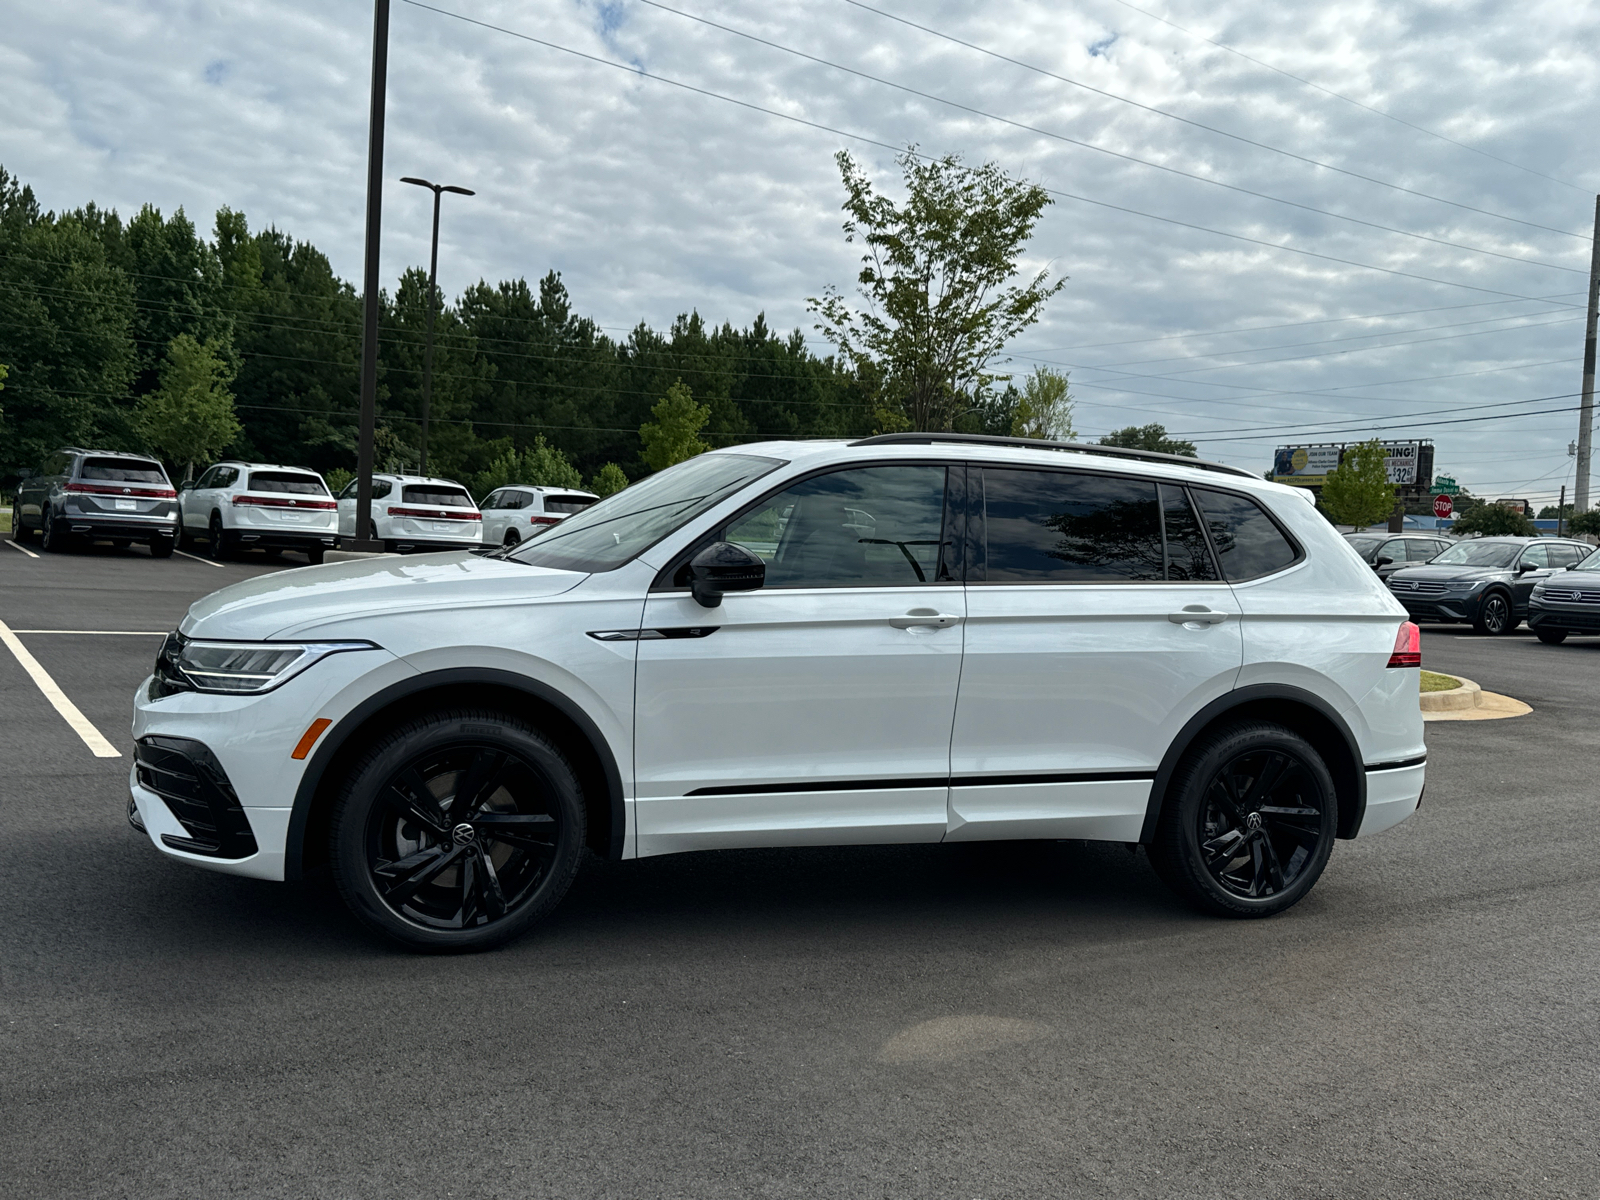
[{"x1": 179, "y1": 550, "x2": 586, "y2": 642}]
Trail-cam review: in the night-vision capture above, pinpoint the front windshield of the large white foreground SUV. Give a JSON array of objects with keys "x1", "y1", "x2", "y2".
[{"x1": 504, "y1": 454, "x2": 782, "y2": 571}]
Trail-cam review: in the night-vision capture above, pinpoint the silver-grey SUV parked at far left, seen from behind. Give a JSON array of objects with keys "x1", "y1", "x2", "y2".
[{"x1": 11, "y1": 446, "x2": 178, "y2": 558}]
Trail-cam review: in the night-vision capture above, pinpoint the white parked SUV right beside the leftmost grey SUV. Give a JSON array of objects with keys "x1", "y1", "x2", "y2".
[{"x1": 178, "y1": 462, "x2": 338, "y2": 565}]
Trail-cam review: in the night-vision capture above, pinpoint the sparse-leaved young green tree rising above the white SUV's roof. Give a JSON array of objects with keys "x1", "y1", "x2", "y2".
[{"x1": 806, "y1": 147, "x2": 1066, "y2": 430}]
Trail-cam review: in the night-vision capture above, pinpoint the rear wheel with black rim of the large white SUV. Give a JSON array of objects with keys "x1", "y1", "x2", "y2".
[{"x1": 1149, "y1": 722, "x2": 1339, "y2": 917}]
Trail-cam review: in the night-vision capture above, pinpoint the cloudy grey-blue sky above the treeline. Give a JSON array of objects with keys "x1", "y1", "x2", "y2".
[{"x1": 0, "y1": 0, "x2": 1600, "y2": 502}]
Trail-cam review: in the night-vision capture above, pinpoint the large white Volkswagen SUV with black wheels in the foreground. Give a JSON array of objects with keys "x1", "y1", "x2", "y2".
[{"x1": 130, "y1": 434, "x2": 1426, "y2": 950}]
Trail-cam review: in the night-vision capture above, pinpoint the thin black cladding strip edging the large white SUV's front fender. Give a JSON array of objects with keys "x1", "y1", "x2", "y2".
[{"x1": 283, "y1": 667, "x2": 627, "y2": 880}]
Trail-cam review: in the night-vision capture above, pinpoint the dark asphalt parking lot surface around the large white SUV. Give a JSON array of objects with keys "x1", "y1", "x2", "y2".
[{"x1": 0, "y1": 546, "x2": 1600, "y2": 1200}]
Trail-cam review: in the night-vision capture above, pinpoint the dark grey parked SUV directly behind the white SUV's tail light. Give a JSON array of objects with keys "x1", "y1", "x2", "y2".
[{"x1": 1389, "y1": 538, "x2": 1589, "y2": 635}]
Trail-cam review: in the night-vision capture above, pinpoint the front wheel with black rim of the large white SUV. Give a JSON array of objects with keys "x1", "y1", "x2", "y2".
[{"x1": 328, "y1": 709, "x2": 586, "y2": 954}]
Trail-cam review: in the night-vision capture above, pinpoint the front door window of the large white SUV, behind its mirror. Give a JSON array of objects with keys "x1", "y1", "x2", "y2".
[{"x1": 723, "y1": 467, "x2": 947, "y2": 587}]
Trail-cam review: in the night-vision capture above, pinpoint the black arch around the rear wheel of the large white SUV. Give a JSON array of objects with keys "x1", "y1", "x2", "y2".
[{"x1": 1139, "y1": 683, "x2": 1366, "y2": 845}]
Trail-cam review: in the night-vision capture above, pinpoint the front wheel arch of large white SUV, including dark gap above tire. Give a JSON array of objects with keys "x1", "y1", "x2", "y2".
[{"x1": 283, "y1": 667, "x2": 627, "y2": 878}]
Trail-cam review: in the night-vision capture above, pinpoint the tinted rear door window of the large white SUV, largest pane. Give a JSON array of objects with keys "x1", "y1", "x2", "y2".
[{"x1": 982, "y1": 469, "x2": 1165, "y2": 582}]
